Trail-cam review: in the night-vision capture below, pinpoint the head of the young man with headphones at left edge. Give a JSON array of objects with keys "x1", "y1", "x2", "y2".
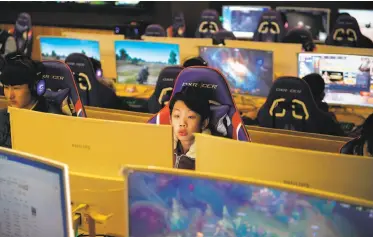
[{"x1": 0, "y1": 54, "x2": 38, "y2": 108}]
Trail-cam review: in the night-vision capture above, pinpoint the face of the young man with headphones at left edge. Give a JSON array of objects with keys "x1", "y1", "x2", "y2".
[{"x1": 4, "y1": 84, "x2": 32, "y2": 108}]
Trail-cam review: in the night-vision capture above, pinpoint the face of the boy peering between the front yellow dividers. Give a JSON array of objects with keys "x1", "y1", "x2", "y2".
[{"x1": 171, "y1": 100, "x2": 202, "y2": 141}]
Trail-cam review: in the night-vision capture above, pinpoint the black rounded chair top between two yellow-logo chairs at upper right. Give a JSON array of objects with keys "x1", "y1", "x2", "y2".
[{"x1": 282, "y1": 28, "x2": 316, "y2": 52}]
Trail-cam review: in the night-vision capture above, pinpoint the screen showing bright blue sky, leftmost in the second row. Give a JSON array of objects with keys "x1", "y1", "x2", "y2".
[{"x1": 40, "y1": 37, "x2": 100, "y2": 61}]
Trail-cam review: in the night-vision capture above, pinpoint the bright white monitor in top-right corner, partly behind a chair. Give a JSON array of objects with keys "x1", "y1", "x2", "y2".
[{"x1": 338, "y1": 9, "x2": 373, "y2": 41}]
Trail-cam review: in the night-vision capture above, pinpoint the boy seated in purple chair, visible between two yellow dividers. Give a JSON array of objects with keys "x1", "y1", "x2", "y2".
[{"x1": 169, "y1": 87, "x2": 211, "y2": 169}]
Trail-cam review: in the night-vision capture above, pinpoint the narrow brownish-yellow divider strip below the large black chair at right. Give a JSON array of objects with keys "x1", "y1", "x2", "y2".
[{"x1": 249, "y1": 130, "x2": 346, "y2": 153}]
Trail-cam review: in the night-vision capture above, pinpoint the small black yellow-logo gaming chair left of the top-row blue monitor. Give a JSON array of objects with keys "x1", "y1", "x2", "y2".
[{"x1": 195, "y1": 9, "x2": 222, "y2": 38}]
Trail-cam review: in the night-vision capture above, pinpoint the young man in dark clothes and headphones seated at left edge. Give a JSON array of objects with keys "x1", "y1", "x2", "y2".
[{"x1": 0, "y1": 56, "x2": 63, "y2": 148}]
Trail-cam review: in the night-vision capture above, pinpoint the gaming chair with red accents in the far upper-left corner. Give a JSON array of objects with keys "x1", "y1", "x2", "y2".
[{"x1": 9, "y1": 12, "x2": 33, "y2": 57}]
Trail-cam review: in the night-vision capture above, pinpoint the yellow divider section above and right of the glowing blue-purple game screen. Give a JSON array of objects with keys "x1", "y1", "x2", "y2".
[{"x1": 225, "y1": 40, "x2": 302, "y2": 79}]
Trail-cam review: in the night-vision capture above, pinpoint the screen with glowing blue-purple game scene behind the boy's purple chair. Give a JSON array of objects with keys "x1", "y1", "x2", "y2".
[{"x1": 199, "y1": 47, "x2": 273, "y2": 96}]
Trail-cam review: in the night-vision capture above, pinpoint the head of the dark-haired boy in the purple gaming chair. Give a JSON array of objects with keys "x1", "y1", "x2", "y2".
[{"x1": 169, "y1": 87, "x2": 210, "y2": 141}]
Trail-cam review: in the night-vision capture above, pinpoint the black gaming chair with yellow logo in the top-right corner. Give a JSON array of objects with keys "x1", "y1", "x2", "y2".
[{"x1": 325, "y1": 14, "x2": 373, "y2": 48}]
